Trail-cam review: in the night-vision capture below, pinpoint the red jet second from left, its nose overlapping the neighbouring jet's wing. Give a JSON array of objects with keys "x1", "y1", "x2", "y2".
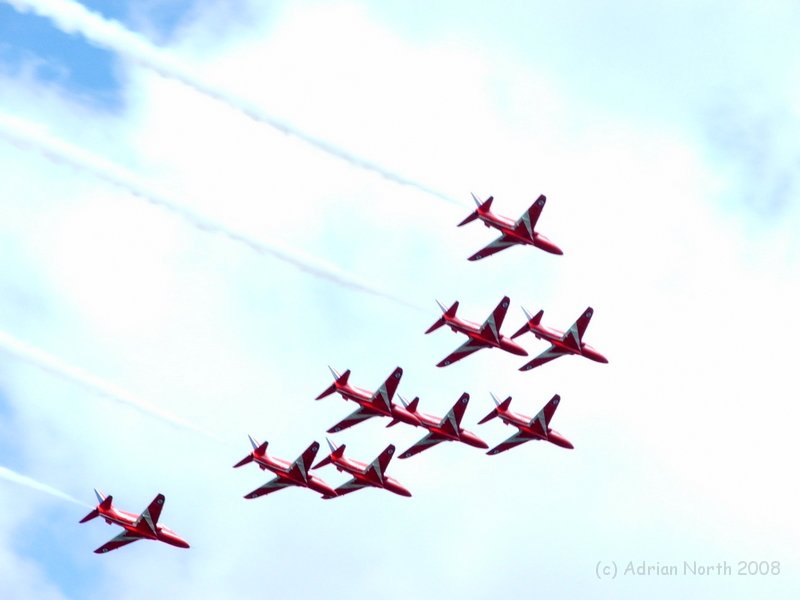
[{"x1": 233, "y1": 436, "x2": 336, "y2": 500}]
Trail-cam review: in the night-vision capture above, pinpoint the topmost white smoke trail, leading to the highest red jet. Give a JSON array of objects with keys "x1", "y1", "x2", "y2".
[{"x1": 5, "y1": 0, "x2": 462, "y2": 206}]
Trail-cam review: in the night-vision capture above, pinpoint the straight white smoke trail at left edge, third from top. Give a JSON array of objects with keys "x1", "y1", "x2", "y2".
[{"x1": 0, "y1": 331, "x2": 224, "y2": 443}]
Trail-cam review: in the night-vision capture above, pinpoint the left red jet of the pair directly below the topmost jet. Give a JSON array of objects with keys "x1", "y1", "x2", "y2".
[{"x1": 425, "y1": 296, "x2": 528, "y2": 367}]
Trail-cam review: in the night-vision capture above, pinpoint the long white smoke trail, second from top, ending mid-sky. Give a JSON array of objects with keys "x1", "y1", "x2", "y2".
[{"x1": 0, "y1": 114, "x2": 422, "y2": 310}]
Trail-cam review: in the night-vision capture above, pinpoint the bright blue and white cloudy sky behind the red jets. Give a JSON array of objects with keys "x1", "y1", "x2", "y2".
[{"x1": 0, "y1": 0, "x2": 800, "y2": 599}]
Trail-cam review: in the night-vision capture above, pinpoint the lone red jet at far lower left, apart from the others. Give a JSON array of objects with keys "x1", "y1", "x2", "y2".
[{"x1": 80, "y1": 490, "x2": 189, "y2": 554}]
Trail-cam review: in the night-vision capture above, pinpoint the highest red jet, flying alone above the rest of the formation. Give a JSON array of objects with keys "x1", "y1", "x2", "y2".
[{"x1": 458, "y1": 194, "x2": 564, "y2": 260}]
